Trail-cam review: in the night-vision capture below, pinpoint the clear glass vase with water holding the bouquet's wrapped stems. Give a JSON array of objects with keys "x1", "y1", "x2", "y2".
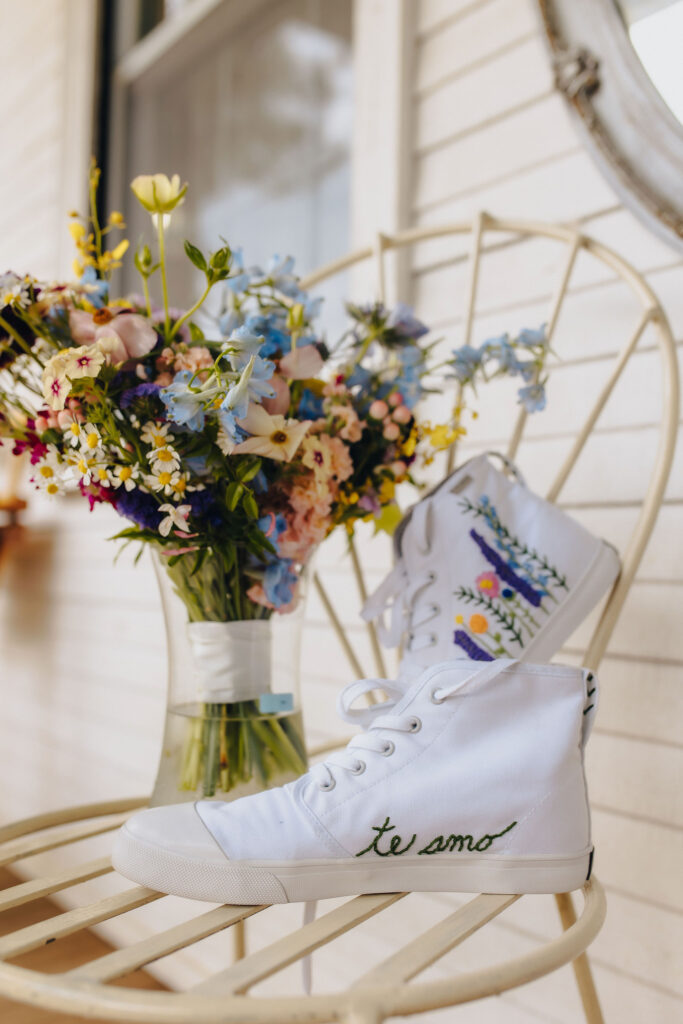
[{"x1": 152, "y1": 555, "x2": 307, "y2": 806}]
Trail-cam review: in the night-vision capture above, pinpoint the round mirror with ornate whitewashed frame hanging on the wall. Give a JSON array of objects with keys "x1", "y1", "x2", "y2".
[{"x1": 540, "y1": 0, "x2": 683, "y2": 252}]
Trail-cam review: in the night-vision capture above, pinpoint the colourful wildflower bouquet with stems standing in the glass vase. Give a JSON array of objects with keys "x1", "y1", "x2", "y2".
[{"x1": 0, "y1": 166, "x2": 545, "y2": 796}]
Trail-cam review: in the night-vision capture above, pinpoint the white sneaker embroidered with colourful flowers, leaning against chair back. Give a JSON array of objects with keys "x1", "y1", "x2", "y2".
[{"x1": 362, "y1": 453, "x2": 620, "y2": 682}]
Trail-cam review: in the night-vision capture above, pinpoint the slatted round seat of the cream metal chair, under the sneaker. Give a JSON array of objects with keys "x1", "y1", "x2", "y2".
[{"x1": 0, "y1": 800, "x2": 605, "y2": 1024}]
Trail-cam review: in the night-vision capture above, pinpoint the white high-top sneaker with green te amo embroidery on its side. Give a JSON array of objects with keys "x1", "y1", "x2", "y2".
[{"x1": 114, "y1": 660, "x2": 597, "y2": 904}]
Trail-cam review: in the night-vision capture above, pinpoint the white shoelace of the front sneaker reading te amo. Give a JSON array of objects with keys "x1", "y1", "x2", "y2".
[{"x1": 310, "y1": 658, "x2": 516, "y2": 793}]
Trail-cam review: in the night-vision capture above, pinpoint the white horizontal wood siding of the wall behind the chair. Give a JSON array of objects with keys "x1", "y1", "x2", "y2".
[{"x1": 0, "y1": 0, "x2": 683, "y2": 1024}]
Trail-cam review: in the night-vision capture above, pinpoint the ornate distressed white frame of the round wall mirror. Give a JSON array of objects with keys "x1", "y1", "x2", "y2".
[{"x1": 539, "y1": 0, "x2": 683, "y2": 253}]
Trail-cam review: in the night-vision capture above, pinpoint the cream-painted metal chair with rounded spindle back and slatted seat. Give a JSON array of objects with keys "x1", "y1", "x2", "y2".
[{"x1": 0, "y1": 214, "x2": 679, "y2": 1024}]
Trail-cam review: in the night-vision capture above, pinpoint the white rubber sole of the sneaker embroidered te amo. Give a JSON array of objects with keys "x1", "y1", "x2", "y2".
[{"x1": 112, "y1": 825, "x2": 592, "y2": 905}]
